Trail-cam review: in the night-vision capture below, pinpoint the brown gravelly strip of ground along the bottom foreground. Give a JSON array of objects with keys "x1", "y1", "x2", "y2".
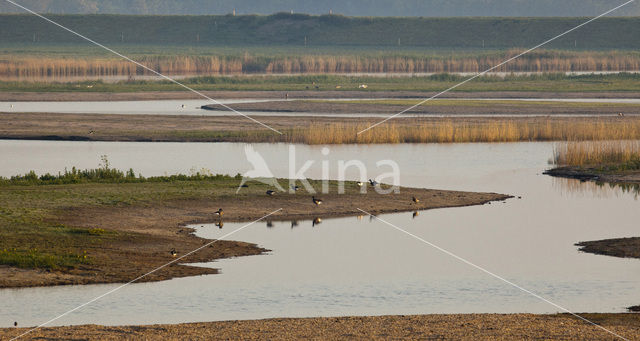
[{"x1": 0, "y1": 314, "x2": 640, "y2": 340}]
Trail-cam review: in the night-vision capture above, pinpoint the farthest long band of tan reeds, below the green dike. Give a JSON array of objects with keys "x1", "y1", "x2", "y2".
[{"x1": 0, "y1": 50, "x2": 640, "y2": 78}]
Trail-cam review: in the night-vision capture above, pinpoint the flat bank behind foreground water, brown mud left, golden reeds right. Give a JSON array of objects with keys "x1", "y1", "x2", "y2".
[{"x1": 0, "y1": 113, "x2": 640, "y2": 144}]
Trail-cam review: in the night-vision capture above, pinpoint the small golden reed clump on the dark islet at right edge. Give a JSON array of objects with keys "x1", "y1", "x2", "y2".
[{"x1": 554, "y1": 140, "x2": 640, "y2": 170}]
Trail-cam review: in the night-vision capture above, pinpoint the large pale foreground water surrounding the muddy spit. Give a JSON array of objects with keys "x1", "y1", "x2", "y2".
[{"x1": 0, "y1": 141, "x2": 640, "y2": 326}]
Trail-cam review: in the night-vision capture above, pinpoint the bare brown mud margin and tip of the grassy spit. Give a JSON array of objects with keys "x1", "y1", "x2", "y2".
[{"x1": 0, "y1": 188, "x2": 510, "y2": 288}]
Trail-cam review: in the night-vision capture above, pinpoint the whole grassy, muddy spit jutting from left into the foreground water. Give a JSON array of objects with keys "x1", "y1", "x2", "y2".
[{"x1": 0, "y1": 177, "x2": 509, "y2": 288}]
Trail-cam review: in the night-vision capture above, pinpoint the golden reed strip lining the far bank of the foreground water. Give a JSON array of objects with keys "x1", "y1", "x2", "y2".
[{"x1": 290, "y1": 118, "x2": 640, "y2": 144}]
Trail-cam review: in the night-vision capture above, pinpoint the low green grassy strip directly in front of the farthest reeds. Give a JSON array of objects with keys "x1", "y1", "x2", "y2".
[{"x1": 0, "y1": 73, "x2": 640, "y2": 92}]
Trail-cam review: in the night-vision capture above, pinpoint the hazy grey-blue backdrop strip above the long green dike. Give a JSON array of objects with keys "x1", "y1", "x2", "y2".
[{"x1": 0, "y1": 0, "x2": 640, "y2": 17}]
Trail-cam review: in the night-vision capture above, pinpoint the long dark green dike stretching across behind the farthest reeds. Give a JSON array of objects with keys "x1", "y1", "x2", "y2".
[{"x1": 0, "y1": 13, "x2": 640, "y2": 49}]
